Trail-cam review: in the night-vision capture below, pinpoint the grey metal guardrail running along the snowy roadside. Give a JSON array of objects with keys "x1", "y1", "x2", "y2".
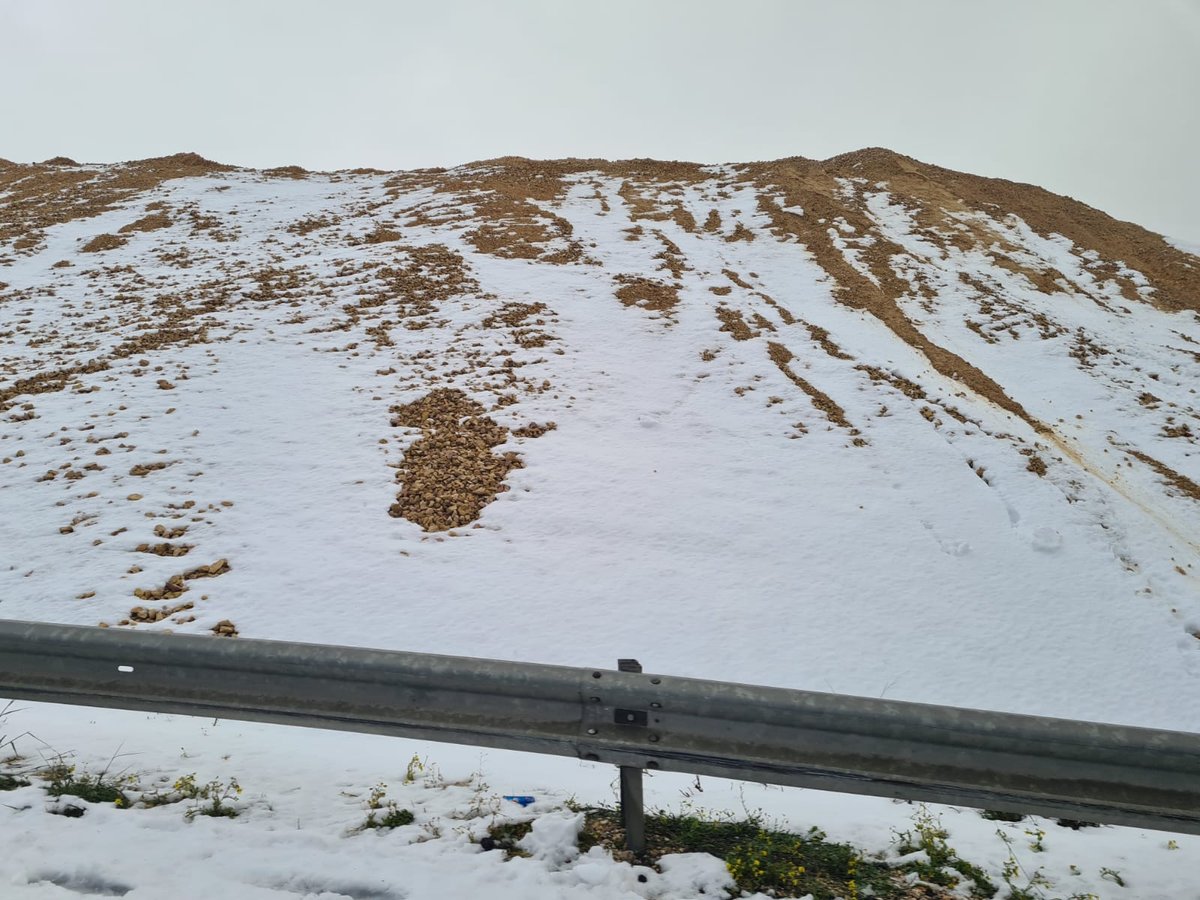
[{"x1": 0, "y1": 620, "x2": 1200, "y2": 834}]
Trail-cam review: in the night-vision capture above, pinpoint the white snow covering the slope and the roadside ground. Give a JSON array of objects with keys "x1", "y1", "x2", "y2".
[{"x1": 0, "y1": 164, "x2": 1200, "y2": 899}]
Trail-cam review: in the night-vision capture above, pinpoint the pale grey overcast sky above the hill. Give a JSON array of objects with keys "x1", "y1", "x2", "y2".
[{"x1": 7, "y1": 0, "x2": 1200, "y2": 241}]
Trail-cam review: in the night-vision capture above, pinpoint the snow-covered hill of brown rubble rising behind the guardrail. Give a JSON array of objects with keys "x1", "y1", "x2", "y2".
[{"x1": 0, "y1": 150, "x2": 1200, "y2": 896}]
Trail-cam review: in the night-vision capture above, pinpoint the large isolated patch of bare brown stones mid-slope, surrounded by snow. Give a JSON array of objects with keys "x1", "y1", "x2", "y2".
[{"x1": 388, "y1": 389, "x2": 521, "y2": 532}]
